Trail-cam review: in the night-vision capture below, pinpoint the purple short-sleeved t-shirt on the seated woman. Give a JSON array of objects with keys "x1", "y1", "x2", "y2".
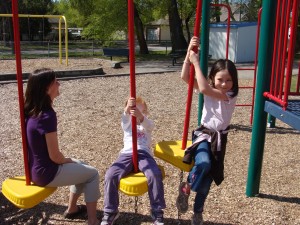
[{"x1": 26, "y1": 109, "x2": 58, "y2": 186}]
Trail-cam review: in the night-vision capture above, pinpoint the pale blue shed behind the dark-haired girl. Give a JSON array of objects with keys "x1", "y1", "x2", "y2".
[{"x1": 209, "y1": 22, "x2": 257, "y2": 63}]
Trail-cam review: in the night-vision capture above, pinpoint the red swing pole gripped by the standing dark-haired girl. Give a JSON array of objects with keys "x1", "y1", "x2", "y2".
[{"x1": 181, "y1": 0, "x2": 202, "y2": 150}]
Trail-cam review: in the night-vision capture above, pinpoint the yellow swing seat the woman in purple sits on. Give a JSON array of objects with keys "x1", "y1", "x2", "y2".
[{"x1": 2, "y1": 176, "x2": 57, "y2": 209}]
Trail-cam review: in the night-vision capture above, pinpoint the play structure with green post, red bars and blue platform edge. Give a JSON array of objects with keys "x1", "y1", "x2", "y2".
[{"x1": 246, "y1": 0, "x2": 300, "y2": 197}]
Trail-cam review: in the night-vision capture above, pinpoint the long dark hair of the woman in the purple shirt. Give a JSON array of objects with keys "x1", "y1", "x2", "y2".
[{"x1": 24, "y1": 68, "x2": 56, "y2": 116}]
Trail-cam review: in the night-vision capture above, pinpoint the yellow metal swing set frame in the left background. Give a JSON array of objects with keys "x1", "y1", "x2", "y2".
[{"x1": 0, "y1": 14, "x2": 69, "y2": 66}]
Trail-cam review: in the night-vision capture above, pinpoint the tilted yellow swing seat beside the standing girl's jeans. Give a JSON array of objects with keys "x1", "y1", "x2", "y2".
[{"x1": 154, "y1": 141, "x2": 194, "y2": 172}]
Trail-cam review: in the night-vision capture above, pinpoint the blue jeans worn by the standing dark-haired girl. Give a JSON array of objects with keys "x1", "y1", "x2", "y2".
[{"x1": 187, "y1": 141, "x2": 213, "y2": 213}]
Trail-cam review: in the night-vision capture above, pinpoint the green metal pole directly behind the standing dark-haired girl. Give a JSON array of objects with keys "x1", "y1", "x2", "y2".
[{"x1": 198, "y1": 0, "x2": 210, "y2": 125}]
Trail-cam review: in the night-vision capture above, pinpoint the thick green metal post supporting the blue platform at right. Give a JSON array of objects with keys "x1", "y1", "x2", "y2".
[{"x1": 246, "y1": 0, "x2": 277, "y2": 197}]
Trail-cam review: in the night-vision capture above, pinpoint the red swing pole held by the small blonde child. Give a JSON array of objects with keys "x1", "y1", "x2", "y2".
[{"x1": 128, "y1": 0, "x2": 138, "y2": 173}]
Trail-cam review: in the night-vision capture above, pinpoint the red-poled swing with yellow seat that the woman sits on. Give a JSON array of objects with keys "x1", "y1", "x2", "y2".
[{"x1": 2, "y1": 0, "x2": 56, "y2": 208}]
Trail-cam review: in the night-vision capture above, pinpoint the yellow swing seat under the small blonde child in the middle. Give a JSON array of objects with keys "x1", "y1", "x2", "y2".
[{"x1": 119, "y1": 165, "x2": 165, "y2": 196}]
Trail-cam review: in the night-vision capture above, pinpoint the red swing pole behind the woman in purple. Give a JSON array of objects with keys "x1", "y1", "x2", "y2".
[{"x1": 12, "y1": 0, "x2": 30, "y2": 185}]
